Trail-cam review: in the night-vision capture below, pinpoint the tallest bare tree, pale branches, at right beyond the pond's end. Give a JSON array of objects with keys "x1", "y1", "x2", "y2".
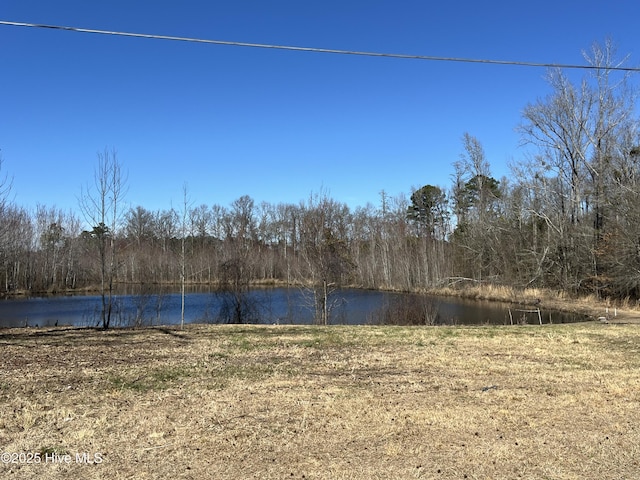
[{"x1": 520, "y1": 40, "x2": 637, "y2": 293}]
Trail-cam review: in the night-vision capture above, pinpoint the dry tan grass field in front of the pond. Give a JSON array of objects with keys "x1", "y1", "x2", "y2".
[{"x1": 0, "y1": 323, "x2": 640, "y2": 480}]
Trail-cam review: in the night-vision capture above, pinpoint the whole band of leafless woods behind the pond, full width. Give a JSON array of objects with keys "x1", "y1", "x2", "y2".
[{"x1": 0, "y1": 42, "x2": 640, "y2": 304}]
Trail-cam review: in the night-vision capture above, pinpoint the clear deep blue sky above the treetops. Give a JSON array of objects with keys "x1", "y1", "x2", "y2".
[{"x1": 0, "y1": 0, "x2": 640, "y2": 218}]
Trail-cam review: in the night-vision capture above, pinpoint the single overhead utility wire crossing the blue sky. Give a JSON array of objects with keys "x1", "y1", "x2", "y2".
[{"x1": 0, "y1": 20, "x2": 640, "y2": 72}]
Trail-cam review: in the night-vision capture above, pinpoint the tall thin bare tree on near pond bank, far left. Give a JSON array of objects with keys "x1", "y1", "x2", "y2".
[{"x1": 79, "y1": 148, "x2": 127, "y2": 329}]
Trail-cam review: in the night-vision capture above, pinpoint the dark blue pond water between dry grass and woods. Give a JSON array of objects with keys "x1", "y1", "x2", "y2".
[{"x1": 0, "y1": 288, "x2": 584, "y2": 327}]
